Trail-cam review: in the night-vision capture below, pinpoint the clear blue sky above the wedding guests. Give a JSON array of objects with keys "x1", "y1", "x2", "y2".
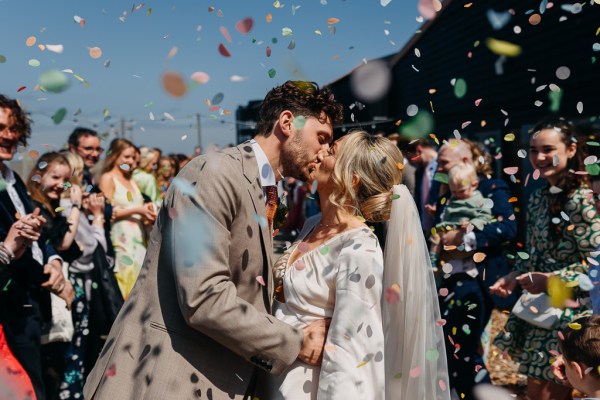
[{"x1": 0, "y1": 0, "x2": 420, "y2": 153}]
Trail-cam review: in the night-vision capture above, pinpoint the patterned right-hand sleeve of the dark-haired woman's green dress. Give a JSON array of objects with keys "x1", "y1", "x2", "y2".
[{"x1": 555, "y1": 189, "x2": 600, "y2": 282}]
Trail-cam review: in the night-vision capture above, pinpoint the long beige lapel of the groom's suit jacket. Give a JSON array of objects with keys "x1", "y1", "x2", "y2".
[{"x1": 237, "y1": 143, "x2": 274, "y2": 306}]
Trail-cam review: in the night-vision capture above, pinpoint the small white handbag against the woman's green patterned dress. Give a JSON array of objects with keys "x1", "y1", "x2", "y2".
[{"x1": 512, "y1": 292, "x2": 563, "y2": 330}]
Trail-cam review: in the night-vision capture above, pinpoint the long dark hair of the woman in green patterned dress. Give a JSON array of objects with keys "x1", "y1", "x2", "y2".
[{"x1": 530, "y1": 117, "x2": 589, "y2": 239}]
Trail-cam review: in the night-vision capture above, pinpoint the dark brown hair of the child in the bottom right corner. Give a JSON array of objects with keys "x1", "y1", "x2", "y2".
[{"x1": 560, "y1": 315, "x2": 600, "y2": 378}]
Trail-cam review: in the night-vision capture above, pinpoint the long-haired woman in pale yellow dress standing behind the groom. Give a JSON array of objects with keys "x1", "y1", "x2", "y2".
[{"x1": 100, "y1": 139, "x2": 156, "y2": 298}]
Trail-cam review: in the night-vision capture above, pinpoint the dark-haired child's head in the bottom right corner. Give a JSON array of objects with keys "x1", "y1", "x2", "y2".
[{"x1": 552, "y1": 315, "x2": 600, "y2": 400}]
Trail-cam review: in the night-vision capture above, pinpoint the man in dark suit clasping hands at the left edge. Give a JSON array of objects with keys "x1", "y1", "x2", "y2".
[{"x1": 0, "y1": 95, "x2": 74, "y2": 399}]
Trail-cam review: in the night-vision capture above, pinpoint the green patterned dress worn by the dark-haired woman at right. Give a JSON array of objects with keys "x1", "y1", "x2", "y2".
[{"x1": 495, "y1": 187, "x2": 600, "y2": 383}]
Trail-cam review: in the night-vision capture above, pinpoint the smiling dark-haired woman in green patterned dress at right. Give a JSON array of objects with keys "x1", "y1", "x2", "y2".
[{"x1": 491, "y1": 118, "x2": 600, "y2": 400}]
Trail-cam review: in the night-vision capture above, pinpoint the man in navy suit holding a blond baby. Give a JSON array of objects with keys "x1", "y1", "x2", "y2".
[{"x1": 435, "y1": 139, "x2": 517, "y2": 400}]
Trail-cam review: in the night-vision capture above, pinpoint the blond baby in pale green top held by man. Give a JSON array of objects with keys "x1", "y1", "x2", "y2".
[{"x1": 430, "y1": 163, "x2": 493, "y2": 266}]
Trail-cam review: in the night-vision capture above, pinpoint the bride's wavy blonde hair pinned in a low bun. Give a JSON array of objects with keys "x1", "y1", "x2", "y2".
[{"x1": 329, "y1": 131, "x2": 404, "y2": 222}]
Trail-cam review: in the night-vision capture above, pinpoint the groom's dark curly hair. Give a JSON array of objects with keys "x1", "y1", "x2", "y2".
[{"x1": 256, "y1": 81, "x2": 344, "y2": 136}]
